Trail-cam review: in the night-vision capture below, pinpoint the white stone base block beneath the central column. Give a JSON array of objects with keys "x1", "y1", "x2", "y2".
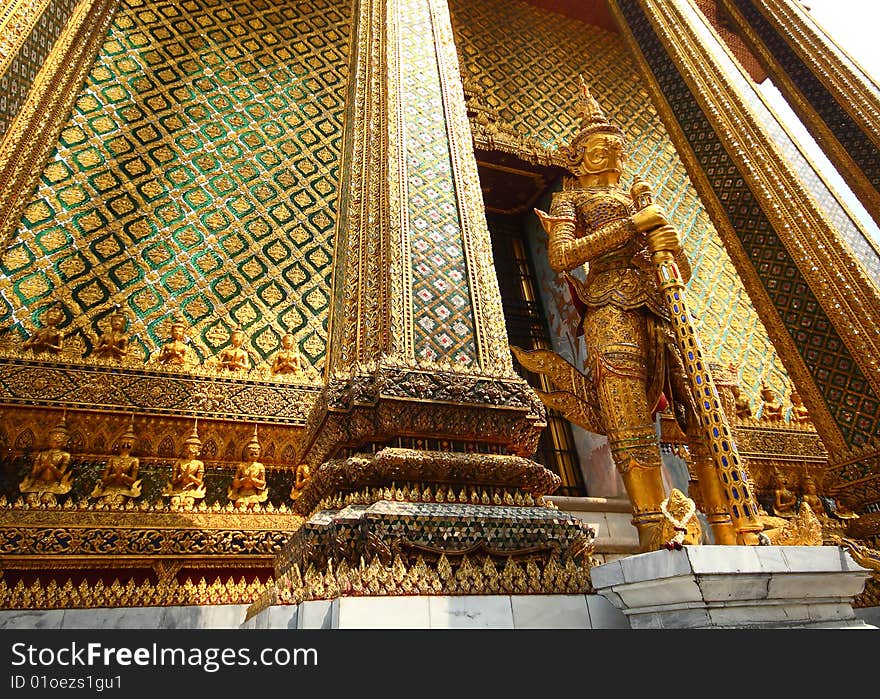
[{"x1": 248, "y1": 595, "x2": 629, "y2": 629}]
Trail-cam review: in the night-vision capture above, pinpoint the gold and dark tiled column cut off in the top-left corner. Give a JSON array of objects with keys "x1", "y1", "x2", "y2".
[{"x1": 0, "y1": 0, "x2": 117, "y2": 246}]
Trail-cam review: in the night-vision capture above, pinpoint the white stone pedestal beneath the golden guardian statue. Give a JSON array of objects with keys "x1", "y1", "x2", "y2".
[{"x1": 591, "y1": 546, "x2": 876, "y2": 629}]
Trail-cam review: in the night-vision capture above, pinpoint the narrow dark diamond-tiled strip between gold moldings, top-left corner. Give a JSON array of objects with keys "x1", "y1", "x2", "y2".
[{"x1": 0, "y1": 0, "x2": 79, "y2": 139}]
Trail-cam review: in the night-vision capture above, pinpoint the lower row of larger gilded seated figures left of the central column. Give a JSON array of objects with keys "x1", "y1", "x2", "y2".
[{"x1": 18, "y1": 417, "x2": 309, "y2": 508}]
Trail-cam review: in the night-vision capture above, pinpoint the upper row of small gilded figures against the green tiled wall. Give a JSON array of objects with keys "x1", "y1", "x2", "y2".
[{"x1": 21, "y1": 306, "x2": 303, "y2": 374}]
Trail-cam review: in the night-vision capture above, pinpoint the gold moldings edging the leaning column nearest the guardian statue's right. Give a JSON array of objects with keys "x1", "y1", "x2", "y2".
[{"x1": 611, "y1": 2, "x2": 880, "y2": 448}]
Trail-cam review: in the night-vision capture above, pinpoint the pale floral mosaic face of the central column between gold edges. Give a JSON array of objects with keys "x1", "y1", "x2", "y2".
[{"x1": 400, "y1": 0, "x2": 477, "y2": 366}]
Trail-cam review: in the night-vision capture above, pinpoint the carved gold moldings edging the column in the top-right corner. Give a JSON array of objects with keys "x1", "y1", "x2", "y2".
[{"x1": 722, "y1": 0, "x2": 880, "y2": 227}]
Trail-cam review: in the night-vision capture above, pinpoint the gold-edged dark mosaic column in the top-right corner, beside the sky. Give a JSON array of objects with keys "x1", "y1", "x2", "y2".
[{"x1": 721, "y1": 0, "x2": 880, "y2": 230}]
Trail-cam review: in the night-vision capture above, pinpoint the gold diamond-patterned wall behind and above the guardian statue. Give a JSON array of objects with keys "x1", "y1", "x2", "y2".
[{"x1": 450, "y1": 0, "x2": 790, "y2": 406}]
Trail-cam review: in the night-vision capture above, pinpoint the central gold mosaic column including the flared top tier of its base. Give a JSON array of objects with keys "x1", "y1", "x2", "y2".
[{"x1": 302, "y1": 0, "x2": 543, "y2": 466}]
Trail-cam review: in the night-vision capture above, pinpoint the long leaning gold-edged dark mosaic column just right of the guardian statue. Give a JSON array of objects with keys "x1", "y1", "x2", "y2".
[{"x1": 610, "y1": 0, "x2": 880, "y2": 478}]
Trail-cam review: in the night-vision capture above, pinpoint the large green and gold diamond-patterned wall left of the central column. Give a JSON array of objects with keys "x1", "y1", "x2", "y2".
[{"x1": 0, "y1": 0, "x2": 351, "y2": 366}]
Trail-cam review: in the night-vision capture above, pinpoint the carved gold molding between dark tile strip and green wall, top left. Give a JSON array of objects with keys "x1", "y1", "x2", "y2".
[{"x1": 0, "y1": 0, "x2": 117, "y2": 249}]
